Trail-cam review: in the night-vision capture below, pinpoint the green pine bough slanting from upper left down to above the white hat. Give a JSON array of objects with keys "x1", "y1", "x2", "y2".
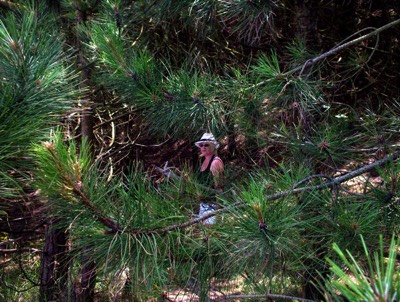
[{"x1": 90, "y1": 16, "x2": 233, "y2": 137}]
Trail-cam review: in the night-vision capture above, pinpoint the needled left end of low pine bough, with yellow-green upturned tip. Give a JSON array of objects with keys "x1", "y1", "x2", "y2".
[{"x1": 34, "y1": 132, "x2": 231, "y2": 294}]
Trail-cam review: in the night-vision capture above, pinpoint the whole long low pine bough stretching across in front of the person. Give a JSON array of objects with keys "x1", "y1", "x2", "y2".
[{"x1": 34, "y1": 125, "x2": 400, "y2": 296}]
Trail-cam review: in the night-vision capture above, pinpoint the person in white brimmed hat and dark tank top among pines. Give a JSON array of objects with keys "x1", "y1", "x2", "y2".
[{"x1": 195, "y1": 132, "x2": 224, "y2": 225}]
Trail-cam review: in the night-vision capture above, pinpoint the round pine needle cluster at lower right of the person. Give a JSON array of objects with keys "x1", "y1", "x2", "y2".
[{"x1": 214, "y1": 167, "x2": 323, "y2": 291}]
